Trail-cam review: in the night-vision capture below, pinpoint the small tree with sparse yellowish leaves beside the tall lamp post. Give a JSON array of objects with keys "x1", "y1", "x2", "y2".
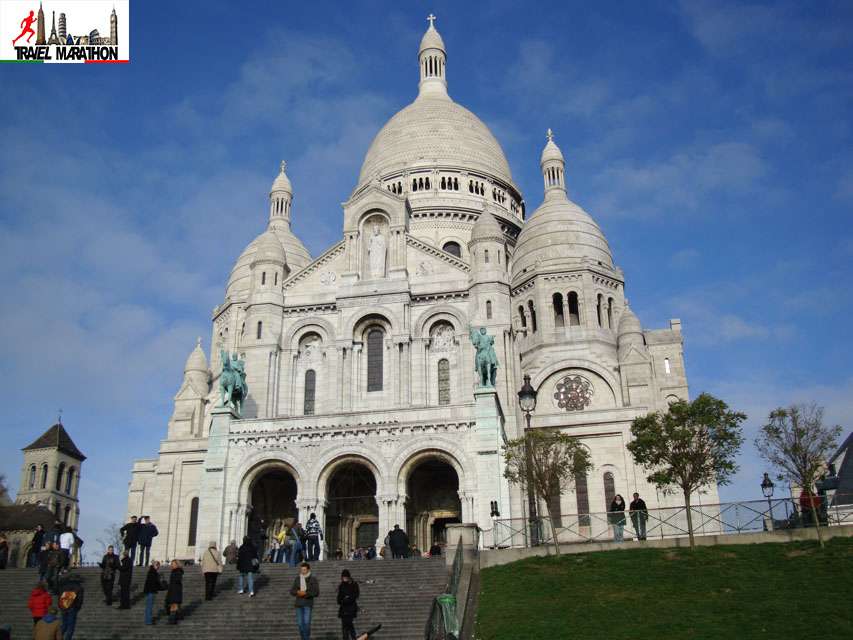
[{"x1": 504, "y1": 431, "x2": 592, "y2": 555}]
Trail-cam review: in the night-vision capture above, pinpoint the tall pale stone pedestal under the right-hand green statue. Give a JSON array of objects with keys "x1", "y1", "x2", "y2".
[{"x1": 470, "y1": 387, "x2": 510, "y2": 542}]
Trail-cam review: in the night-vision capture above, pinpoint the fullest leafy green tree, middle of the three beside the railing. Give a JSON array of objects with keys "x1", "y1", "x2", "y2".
[{"x1": 628, "y1": 393, "x2": 746, "y2": 549}]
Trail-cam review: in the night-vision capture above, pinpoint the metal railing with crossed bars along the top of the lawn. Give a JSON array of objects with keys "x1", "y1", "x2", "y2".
[{"x1": 484, "y1": 494, "x2": 853, "y2": 548}]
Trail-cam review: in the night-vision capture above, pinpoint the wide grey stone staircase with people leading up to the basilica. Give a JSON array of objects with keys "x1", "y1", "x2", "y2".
[{"x1": 0, "y1": 558, "x2": 447, "y2": 640}]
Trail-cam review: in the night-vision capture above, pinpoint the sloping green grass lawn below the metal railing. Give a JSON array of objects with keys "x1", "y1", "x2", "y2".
[{"x1": 476, "y1": 538, "x2": 853, "y2": 640}]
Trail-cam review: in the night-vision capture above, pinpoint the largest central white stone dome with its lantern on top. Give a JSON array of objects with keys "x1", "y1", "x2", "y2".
[{"x1": 358, "y1": 24, "x2": 512, "y2": 189}]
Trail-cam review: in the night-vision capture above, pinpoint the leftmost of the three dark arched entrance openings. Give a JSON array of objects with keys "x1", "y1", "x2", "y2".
[{"x1": 246, "y1": 467, "x2": 299, "y2": 553}]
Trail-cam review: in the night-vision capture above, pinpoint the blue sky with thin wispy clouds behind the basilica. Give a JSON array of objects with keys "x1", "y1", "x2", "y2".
[{"x1": 0, "y1": 0, "x2": 853, "y2": 552}]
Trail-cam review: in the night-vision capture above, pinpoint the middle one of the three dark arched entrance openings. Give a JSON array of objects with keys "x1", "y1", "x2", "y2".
[{"x1": 326, "y1": 462, "x2": 379, "y2": 557}]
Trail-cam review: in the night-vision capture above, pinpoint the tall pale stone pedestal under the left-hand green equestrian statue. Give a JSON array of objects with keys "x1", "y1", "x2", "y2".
[{"x1": 195, "y1": 407, "x2": 238, "y2": 559}]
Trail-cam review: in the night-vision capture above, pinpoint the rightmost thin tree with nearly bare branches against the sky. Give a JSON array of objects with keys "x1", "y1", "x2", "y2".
[{"x1": 755, "y1": 403, "x2": 841, "y2": 547}]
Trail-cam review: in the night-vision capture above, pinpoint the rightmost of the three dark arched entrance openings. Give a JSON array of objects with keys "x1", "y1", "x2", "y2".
[{"x1": 406, "y1": 458, "x2": 462, "y2": 552}]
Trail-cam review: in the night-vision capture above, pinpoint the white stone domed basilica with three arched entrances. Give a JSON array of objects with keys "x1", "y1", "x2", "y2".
[{"x1": 128, "y1": 17, "x2": 716, "y2": 558}]
